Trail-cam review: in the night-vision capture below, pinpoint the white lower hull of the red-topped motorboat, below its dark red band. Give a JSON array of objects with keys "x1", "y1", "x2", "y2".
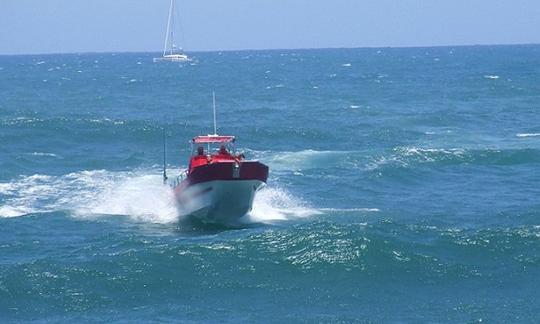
[{"x1": 176, "y1": 180, "x2": 264, "y2": 224}]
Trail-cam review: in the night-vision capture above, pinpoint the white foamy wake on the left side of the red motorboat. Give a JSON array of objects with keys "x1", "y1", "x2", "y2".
[{"x1": 0, "y1": 170, "x2": 176, "y2": 223}]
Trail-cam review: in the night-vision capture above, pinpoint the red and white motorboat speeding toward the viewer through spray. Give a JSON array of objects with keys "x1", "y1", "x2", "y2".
[{"x1": 163, "y1": 96, "x2": 268, "y2": 224}]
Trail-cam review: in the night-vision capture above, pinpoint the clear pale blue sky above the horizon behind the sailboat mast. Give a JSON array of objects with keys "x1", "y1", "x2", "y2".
[{"x1": 0, "y1": 0, "x2": 540, "y2": 54}]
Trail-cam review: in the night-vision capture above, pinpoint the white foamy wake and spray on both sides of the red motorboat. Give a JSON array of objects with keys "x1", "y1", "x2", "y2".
[{"x1": 0, "y1": 169, "x2": 319, "y2": 223}]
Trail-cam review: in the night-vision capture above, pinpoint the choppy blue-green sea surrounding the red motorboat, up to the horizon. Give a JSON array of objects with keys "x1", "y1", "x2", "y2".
[{"x1": 0, "y1": 45, "x2": 540, "y2": 323}]
